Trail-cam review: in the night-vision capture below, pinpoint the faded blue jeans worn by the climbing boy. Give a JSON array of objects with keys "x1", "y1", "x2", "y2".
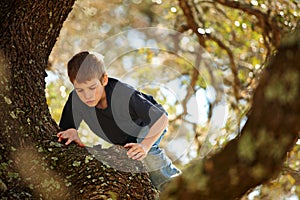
[{"x1": 137, "y1": 128, "x2": 181, "y2": 189}]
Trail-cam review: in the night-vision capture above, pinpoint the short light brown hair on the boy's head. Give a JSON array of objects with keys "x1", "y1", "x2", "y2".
[{"x1": 68, "y1": 51, "x2": 105, "y2": 83}]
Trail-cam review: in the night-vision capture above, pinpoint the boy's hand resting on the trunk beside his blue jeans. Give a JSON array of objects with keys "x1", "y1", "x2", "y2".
[{"x1": 124, "y1": 143, "x2": 149, "y2": 160}]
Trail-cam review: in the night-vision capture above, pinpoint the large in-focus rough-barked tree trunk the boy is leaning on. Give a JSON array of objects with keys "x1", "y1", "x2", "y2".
[{"x1": 0, "y1": 0, "x2": 158, "y2": 199}]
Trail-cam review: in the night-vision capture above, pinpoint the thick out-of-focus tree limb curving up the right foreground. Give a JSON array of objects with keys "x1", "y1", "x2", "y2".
[{"x1": 161, "y1": 32, "x2": 300, "y2": 200}]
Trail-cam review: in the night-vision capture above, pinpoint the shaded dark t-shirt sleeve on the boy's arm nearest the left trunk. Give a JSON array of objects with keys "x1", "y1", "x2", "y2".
[{"x1": 59, "y1": 93, "x2": 77, "y2": 131}]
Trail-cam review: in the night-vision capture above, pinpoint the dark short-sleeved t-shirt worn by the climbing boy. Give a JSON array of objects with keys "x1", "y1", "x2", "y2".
[{"x1": 59, "y1": 78, "x2": 166, "y2": 145}]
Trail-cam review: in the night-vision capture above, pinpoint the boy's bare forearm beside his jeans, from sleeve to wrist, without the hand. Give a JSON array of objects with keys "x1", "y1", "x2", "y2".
[{"x1": 141, "y1": 114, "x2": 168, "y2": 152}]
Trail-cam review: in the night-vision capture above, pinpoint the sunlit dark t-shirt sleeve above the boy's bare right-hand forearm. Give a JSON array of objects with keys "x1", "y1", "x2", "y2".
[{"x1": 130, "y1": 91, "x2": 165, "y2": 127}]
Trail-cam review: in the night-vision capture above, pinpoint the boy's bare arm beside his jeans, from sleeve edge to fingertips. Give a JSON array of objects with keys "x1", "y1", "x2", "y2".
[{"x1": 124, "y1": 114, "x2": 168, "y2": 160}]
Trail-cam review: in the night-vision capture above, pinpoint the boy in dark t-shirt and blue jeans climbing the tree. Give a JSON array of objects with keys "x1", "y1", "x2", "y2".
[{"x1": 57, "y1": 51, "x2": 181, "y2": 188}]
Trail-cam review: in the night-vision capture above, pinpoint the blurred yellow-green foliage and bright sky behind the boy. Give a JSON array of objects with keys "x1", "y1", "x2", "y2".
[{"x1": 46, "y1": 0, "x2": 300, "y2": 200}]
